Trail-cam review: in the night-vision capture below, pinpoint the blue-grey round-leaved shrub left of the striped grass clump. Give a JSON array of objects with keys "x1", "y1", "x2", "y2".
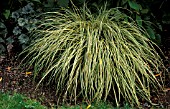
[{"x1": 0, "y1": 1, "x2": 38, "y2": 56}]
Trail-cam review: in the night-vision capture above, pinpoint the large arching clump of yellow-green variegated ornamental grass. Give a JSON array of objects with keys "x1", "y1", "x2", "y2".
[{"x1": 20, "y1": 7, "x2": 162, "y2": 106}]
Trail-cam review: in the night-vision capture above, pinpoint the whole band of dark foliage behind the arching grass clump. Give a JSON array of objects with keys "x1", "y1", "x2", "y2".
[{"x1": 0, "y1": 0, "x2": 170, "y2": 56}]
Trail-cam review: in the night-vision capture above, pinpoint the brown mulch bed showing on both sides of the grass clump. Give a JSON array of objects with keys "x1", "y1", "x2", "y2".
[{"x1": 0, "y1": 50, "x2": 170, "y2": 109}]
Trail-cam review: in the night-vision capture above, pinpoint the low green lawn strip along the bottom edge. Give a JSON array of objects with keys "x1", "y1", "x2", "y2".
[{"x1": 0, "y1": 92, "x2": 131, "y2": 109}]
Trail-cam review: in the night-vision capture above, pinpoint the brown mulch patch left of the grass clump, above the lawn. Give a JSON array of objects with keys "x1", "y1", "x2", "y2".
[{"x1": 0, "y1": 58, "x2": 57, "y2": 107}]
